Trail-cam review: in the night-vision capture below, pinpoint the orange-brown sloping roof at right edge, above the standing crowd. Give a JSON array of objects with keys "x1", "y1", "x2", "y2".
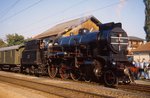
[{"x1": 132, "y1": 42, "x2": 150, "y2": 52}]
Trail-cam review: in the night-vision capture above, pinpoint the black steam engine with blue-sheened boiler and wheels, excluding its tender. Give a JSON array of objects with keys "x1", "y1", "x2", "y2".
[{"x1": 48, "y1": 23, "x2": 131, "y2": 86}]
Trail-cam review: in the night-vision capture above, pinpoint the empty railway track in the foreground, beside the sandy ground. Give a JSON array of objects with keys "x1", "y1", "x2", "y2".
[{"x1": 0, "y1": 71, "x2": 111, "y2": 98}]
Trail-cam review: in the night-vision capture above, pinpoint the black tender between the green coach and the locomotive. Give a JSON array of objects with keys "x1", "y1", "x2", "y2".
[{"x1": 21, "y1": 40, "x2": 47, "y2": 73}]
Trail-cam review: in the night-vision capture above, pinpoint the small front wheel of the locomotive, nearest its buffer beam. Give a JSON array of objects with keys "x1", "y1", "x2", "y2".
[{"x1": 104, "y1": 70, "x2": 118, "y2": 87}]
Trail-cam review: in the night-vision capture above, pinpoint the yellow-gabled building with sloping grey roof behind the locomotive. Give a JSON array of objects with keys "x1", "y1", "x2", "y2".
[{"x1": 33, "y1": 16, "x2": 101, "y2": 39}]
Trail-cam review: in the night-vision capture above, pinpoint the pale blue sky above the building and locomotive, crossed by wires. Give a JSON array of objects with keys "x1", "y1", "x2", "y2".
[{"x1": 0, "y1": 0, "x2": 146, "y2": 41}]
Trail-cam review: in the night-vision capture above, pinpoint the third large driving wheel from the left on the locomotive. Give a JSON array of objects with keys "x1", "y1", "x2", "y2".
[{"x1": 70, "y1": 69, "x2": 81, "y2": 81}]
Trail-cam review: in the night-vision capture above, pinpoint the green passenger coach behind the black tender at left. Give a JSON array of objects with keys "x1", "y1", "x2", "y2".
[{"x1": 0, "y1": 45, "x2": 24, "y2": 69}]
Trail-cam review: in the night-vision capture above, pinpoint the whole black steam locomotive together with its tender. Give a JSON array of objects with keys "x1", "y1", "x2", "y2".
[{"x1": 0, "y1": 23, "x2": 131, "y2": 86}]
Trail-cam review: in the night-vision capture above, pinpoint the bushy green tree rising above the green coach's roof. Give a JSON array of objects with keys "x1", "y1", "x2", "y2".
[{"x1": 6, "y1": 33, "x2": 25, "y2": 46}]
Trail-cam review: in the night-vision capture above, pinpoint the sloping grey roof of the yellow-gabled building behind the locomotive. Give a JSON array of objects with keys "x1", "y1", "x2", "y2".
[{"x1": 34, "y1": 16, "x2": 100, "y2": 39}]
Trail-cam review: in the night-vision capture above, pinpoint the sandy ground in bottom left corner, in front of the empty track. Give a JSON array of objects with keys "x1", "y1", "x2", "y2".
[{"x1": 0, "y1": 81, "x2": 61, "y2": 98}]
